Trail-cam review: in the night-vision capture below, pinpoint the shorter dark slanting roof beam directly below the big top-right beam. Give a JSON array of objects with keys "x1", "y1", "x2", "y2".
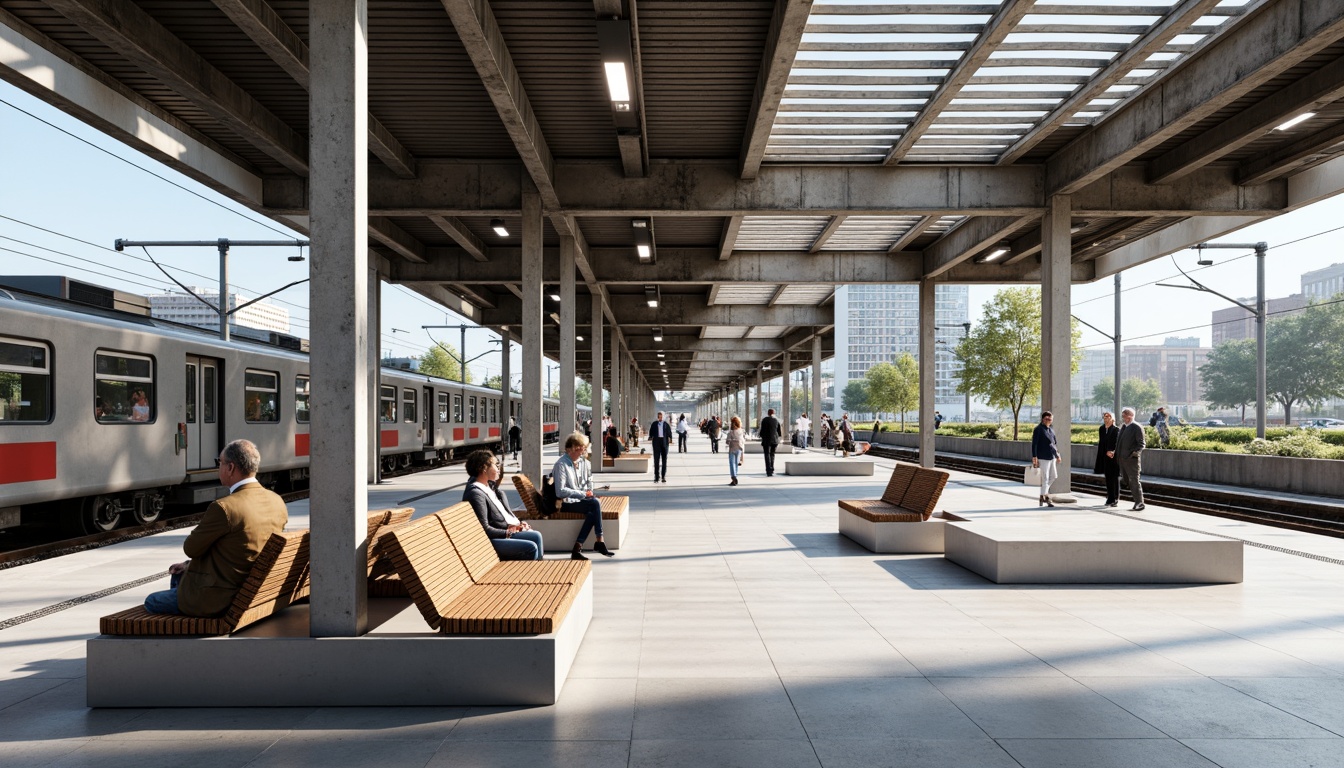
[{"x1": 1148, "y1": 52, "x2": 1344, "y2": 184}]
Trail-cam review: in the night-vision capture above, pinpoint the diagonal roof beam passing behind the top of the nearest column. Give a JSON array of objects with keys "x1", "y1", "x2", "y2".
[{"x1": 212, "y1": 0, "x2": 415, "y2": 179}]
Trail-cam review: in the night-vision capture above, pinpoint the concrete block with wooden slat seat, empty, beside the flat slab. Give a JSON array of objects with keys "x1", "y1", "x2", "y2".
[{"x1": 836, "y1": 464, "x2": 949, "y2": 554}]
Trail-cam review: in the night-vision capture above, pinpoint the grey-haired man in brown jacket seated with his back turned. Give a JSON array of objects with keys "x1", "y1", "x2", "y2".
[{"x1": 145, "y1": 440, "x2": 289, "y2": 616}]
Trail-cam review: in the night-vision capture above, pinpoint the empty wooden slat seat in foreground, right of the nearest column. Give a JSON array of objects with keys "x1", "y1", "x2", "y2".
[{"x1": 379, "y1": 502, "x2": 591, "y2": 635}]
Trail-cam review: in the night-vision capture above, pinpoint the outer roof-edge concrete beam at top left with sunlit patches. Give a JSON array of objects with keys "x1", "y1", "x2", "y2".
[{"x1": 0, "y1": 9, "x2": 262, "y2": 208}]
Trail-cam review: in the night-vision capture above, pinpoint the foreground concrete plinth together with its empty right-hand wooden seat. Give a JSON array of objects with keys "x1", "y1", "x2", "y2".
[{"x1": 87, "y1": 503, "x2": 593, "y2": 706}]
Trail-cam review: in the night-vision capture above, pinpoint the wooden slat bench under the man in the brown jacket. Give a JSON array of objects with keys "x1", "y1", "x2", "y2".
[{"x1": 98, "y1": 531, "x2": 309, "y2": 635}]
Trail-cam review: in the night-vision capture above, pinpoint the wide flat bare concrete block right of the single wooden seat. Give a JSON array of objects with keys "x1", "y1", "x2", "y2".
[{"x1": 943, "y1": 515, "x2": 1242, "y2": 584}]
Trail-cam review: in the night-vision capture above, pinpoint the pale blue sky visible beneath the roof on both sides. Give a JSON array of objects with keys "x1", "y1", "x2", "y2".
[{"x1": 0, "y1": 77, "x2": 1344, "y2": 392}]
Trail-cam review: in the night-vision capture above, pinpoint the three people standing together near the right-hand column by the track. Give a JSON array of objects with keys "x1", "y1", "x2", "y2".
[{"x1": 1031, "y1": 408, "x2": 1148, "y2": 512}]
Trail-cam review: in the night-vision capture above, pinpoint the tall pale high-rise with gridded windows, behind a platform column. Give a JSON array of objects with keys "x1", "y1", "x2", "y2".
[{"x1": 835, "y1": 285, "x2": 970, "y2": 421}]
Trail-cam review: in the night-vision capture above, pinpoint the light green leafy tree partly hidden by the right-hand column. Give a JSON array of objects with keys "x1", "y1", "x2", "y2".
[{"x1": 956, "y1": 288, "x2": 1082, "y2": 440}]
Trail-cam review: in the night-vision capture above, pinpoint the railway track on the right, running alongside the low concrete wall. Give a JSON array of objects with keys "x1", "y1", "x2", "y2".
[{"x1": 868, "y1": 447, "x2": 1344, "y2": 538}]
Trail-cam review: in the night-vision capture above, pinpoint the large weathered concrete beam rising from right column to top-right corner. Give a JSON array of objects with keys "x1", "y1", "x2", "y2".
[{"x1": 1046, "y1": 0, "x2": 1344, "y2": 194}]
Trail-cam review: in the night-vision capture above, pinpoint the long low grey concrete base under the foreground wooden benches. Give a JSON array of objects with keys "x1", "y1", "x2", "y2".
[{"x1": 87, "y1": 578, "x2": 593, "y2": 707}]
